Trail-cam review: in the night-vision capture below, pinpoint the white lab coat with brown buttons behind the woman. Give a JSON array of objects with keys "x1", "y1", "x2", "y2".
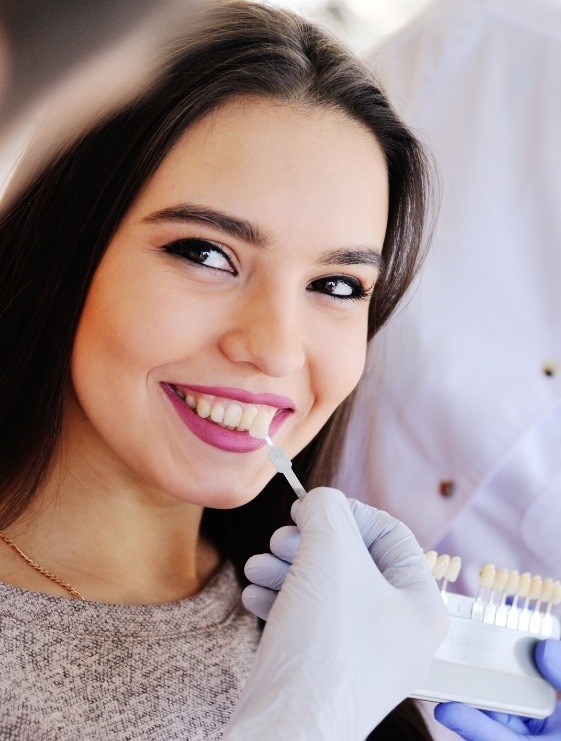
[{"x1": 336, "y1": 0, "x2": 561, "y2": 594}]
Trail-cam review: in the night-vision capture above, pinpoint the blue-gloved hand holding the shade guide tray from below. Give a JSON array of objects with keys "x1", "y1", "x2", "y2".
[{"x1": 434, "y1": 638, "x2": 561, "y2": 741}]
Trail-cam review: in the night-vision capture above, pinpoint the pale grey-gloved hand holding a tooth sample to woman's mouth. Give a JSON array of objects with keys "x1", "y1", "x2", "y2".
[{"x1": 224, "y1": 487, "x2": 448, "y2": 741}]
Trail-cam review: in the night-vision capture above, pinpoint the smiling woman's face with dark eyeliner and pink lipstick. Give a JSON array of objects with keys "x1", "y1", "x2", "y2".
[{"x1": 72, "y1": 99, "x2": 388, "y2": 507}]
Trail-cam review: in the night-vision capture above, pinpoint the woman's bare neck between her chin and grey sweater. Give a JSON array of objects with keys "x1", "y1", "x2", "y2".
[{"x1": 0, "y1": 404, "x2": 220, "y2": 604}]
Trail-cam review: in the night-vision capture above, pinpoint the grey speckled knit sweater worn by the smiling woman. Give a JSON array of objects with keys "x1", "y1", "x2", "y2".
[{"x1": 0, "y1": 564, "x2": 259, "y2": 741}]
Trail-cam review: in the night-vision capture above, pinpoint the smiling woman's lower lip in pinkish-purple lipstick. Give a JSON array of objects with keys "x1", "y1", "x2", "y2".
[{"x1": 161, "y1": 383, "x2": 290, "y2": 453}]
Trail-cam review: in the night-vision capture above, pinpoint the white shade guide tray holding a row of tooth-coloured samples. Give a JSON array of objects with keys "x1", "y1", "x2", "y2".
[{"x1": 411, "y1": 551, "x2": 561, "y2": 718}]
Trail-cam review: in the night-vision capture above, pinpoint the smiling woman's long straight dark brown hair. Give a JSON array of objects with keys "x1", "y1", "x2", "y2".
[{"x1": 0, "y1": 0, "x2": 427, "y2": 736}]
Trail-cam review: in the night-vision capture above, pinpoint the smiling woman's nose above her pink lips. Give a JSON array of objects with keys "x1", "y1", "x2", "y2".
[{"x1": 220, "y1": 284, "x2": 306, "y2": 378}]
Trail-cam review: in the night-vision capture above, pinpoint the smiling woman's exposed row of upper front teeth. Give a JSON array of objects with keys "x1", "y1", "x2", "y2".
[{"x1": 178, "y1": 392, "x2": 276, "y2": 438}]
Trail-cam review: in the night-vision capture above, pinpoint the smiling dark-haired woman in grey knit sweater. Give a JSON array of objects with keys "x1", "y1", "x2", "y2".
[{"x1": 0, "y1": 3, "x2": 440, "y2": 739}]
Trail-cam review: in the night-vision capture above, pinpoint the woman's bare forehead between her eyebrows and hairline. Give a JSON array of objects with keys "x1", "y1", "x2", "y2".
[{"x1": 129, "y1": 98, "x2": 388, "y2": 247}]
